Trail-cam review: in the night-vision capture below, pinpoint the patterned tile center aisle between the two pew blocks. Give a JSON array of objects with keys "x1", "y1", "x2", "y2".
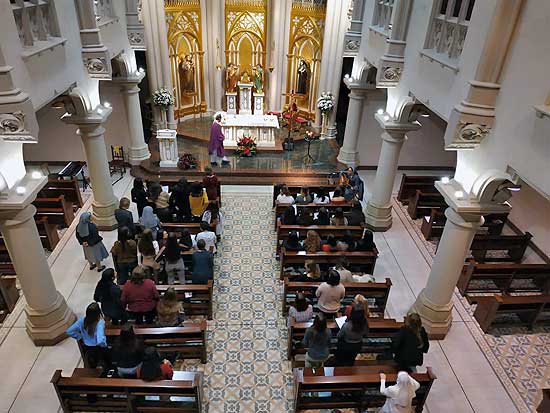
[{"x1": 198, "y1": 186, "x2": 292, "y2": 413}]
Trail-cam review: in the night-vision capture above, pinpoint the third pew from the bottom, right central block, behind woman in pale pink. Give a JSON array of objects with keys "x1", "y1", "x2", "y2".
[{"x1": 283, "y1": 278, "x2": 392, "y2": 317}]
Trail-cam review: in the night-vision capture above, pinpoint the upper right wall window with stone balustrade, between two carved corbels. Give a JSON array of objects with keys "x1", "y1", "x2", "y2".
[{"x1": 424, "y1": 0, "x2": 475, "y2": 61}]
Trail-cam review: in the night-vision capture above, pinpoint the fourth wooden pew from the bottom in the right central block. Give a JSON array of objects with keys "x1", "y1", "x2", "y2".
[{"x1": 280, "y1": 248, "x2": 378, "y2": 280}]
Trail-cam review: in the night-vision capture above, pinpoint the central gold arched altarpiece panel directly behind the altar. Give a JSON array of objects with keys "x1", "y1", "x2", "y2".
[{"x1": 225, "y1": 0, "x2": 267, "y2": 93}]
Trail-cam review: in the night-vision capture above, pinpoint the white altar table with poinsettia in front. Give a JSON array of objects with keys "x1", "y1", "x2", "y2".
[{"x1": 222, "y1": 114, "x2": 279, "y2": 149}]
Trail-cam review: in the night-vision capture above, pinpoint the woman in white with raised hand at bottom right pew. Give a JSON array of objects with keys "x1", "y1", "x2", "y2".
[{"x1": 380, "y1": 371, "x2": 420, "y2": 413}]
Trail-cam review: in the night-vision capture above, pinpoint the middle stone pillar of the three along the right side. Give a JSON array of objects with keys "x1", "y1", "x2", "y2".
[{"x1": 365, "y1": 103, "x2": 420, "y2": 231}]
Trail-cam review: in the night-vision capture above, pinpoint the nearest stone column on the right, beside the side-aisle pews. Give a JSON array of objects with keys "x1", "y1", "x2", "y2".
[{"x1": 411, "y1": 208, "x2": 483, "y2": 339}]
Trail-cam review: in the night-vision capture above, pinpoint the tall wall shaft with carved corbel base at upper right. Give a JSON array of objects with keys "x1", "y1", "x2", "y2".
[{"x1": 445, "y1": 0, "x2": 524, "y2": 150}]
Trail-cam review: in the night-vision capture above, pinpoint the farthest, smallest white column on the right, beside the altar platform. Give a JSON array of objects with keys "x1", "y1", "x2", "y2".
[{"x1": 337, "y1": 82, "x2": 368, "y2": 167}]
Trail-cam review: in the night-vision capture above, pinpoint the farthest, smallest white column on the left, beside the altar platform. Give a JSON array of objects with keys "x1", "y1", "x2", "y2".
[{"x1": 121, "y1": 80, "x2": 151, "y2": 165}]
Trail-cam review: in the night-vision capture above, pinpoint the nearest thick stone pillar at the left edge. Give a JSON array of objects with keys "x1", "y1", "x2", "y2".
[{"x1": 0, "y1": 204, "x2": 76, "y2": 346}]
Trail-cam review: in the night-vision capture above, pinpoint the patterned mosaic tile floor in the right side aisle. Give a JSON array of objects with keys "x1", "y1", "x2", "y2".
[{"x1": 393, "y1": 199, "x2": 550, "y2": 412}]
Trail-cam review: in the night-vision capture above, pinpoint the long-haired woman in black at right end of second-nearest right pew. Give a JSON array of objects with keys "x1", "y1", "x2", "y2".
[{"x1": 392, "y1": 313, "x2": 430, "y2": 372}]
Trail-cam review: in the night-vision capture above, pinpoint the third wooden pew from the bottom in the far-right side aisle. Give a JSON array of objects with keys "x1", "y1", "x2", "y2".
[{"x1": 470, "y1": 232, "x2": 533, "y2": 263}]
